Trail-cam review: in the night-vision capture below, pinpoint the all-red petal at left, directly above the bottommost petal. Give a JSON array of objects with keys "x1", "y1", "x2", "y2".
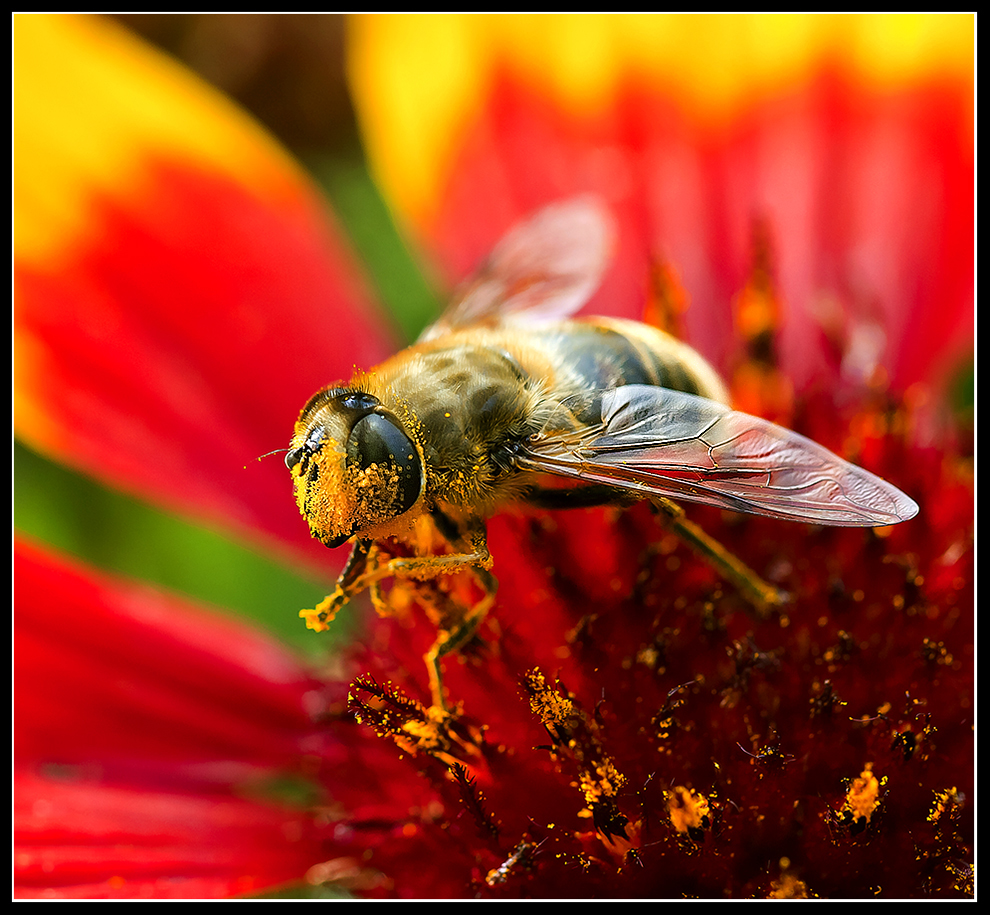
[{"x1": 14, "y1": 543, "x2": 315, "y2": 776}]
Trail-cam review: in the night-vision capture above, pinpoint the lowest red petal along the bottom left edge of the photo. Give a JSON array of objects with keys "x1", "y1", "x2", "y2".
[{"x1": 14, "y1": 771, "x2": 319, "y2": 899}]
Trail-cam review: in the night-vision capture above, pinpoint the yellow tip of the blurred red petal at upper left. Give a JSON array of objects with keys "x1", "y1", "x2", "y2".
[{"x1": 14, "y1": 15, "x2": 300, "y2": 268}]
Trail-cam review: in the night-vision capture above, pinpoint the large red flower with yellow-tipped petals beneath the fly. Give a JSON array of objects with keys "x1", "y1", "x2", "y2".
[{"x1": 15, "y1": 17, "x2": 973, "y2": 898}]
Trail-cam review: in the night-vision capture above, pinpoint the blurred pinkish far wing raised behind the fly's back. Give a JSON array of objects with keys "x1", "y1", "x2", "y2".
[{"x1": 420, "y1": 196, "x2": 613, "y2": 341}]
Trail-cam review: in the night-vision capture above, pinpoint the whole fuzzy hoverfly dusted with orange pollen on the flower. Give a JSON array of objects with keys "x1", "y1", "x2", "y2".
[{"x1": 286, "y1": 198, "x2": 918, "y2": 707}]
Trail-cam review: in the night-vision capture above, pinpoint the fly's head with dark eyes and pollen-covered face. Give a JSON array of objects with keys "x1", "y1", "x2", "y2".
[{"x1": 285, "y1": 388, "x2": 425, "y2": 547}]
